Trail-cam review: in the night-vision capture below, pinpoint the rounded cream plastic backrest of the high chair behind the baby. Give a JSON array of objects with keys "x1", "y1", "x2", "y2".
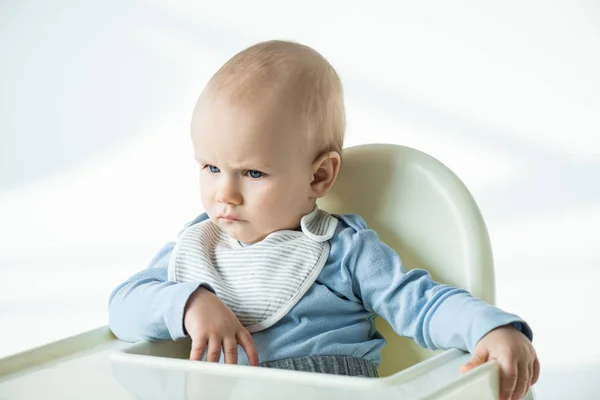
[{"x1": 319, "y1": 144, "x2": 494, "y2": 376}]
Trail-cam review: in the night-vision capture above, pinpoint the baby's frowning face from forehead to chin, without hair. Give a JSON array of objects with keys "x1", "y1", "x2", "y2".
[{"x1": 192, "y1": 92, "x2": 315, "y2": 243}]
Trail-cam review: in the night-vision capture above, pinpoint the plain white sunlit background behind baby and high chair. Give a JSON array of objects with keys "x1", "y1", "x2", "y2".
[{"x1": 0, "y1": 0, "x2": 600, "y2": 399}]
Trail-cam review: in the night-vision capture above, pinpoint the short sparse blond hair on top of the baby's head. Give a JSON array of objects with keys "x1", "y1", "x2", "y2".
[{"x1": 205, "y1": 40, "x2": 346, "y2": 156}]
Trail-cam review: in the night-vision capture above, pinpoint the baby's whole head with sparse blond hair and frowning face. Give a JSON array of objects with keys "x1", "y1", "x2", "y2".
[{"x1": 192, "y1": 41, "x2": 345, "y2": 243}]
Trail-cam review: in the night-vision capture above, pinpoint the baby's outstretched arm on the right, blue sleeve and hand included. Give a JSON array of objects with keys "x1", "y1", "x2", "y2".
[{"x1": 345, "y1": 222, "x2": 539, "y2": 400}]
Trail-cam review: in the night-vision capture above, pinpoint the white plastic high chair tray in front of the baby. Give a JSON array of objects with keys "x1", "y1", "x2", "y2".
[{"x1": 0, "y1": 327, "x2": 498, "y2": 400}]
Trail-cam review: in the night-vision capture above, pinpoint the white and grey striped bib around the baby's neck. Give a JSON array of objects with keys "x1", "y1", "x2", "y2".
[{"x1": 168, "y1": 207, "x2": 338, "y2": 333}]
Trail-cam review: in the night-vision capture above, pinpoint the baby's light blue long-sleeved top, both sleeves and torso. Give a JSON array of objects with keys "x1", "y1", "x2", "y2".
[{"x1": 109, "y1": 214, "x2": 532, "y2": 364}]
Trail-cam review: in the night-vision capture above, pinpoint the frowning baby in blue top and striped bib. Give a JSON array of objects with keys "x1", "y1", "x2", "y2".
[{"x1": 109, "y1": 41, "x2": 539, "y2": 399}]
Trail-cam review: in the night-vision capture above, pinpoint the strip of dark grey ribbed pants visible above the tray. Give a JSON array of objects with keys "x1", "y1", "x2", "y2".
[{"x1": 260, "y1": 356, "x2": 379, "y2": 378}]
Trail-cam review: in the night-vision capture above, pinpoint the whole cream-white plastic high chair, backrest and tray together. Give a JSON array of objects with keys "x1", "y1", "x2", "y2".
[{"x1": 0, "y1": 145, "x2": 533, "y2": 400}]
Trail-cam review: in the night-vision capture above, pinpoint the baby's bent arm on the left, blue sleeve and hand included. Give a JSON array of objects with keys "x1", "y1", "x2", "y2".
[{"x1": 109, "y1": 230, "x2": 258, "y2": 365}]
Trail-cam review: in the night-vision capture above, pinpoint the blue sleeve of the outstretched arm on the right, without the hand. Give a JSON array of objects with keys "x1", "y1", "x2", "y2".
[{"x1": 342, "y1": 216, "x2": 532, "y2": 352}]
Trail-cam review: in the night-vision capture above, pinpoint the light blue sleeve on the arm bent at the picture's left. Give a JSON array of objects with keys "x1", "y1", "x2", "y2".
[{"x1": 108, "y1": 217, "x2": 212, "y2": 342}]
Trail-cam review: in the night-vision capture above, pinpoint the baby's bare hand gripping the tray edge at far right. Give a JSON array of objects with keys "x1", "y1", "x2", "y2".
[{"x1": 461, "y1": 325, "x2": 540, "y2": 400}]
